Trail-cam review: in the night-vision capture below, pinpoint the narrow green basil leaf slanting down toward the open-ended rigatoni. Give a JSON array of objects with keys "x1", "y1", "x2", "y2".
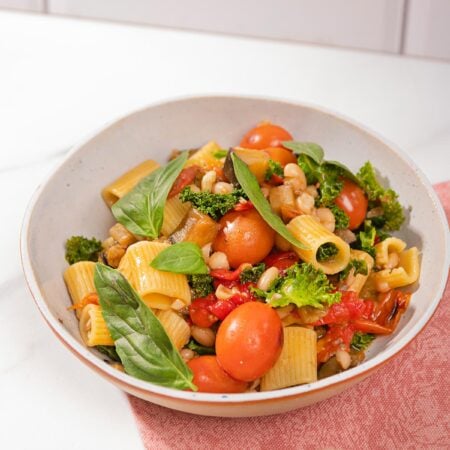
[{"x1": 231, "y1": 153, "x2": 308, "y2": 249}]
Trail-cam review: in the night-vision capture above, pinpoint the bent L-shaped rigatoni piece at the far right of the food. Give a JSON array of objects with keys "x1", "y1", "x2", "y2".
[{"x1": 373, "y1": 247, "x2": 420, "y2": 289}]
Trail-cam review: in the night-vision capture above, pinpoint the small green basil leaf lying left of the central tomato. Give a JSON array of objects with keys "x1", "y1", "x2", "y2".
[{"x1": 150, "y1": 242, "x2": 208, "y2": 275}]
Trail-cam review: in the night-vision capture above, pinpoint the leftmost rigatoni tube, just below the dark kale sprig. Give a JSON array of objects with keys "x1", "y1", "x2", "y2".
[{"x1": 64, "y1": 261, "x2": 96, "y2": 318}]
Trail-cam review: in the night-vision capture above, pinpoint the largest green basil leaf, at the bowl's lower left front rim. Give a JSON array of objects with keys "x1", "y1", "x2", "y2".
[{"x1": 94, "y1": 263, "x2": 197, "y2": 390}]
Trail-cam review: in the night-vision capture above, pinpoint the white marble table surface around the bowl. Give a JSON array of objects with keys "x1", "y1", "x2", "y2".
[{"x1": 0, "y1": 7, "x2": 450, "y2": 450}]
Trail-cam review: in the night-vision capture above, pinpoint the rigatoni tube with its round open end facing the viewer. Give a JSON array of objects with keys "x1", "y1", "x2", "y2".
[{"x1": 287, "y1": 215, "x2": 350, "y2": 275}]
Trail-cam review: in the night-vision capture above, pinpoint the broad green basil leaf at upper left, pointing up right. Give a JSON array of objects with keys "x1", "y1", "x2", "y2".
[{"x1": 112, "y1": 152, "x2": 188, "y2": 239}]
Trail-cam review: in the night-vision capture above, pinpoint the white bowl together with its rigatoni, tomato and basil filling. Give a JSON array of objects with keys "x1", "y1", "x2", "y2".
[{"x1": 23, "y1": 98, "x2": 448, "y2": 416}]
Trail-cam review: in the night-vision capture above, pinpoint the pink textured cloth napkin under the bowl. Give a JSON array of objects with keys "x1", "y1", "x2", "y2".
[{"x1": 130, "y1": 182, "x2": 450, "y2": 450}]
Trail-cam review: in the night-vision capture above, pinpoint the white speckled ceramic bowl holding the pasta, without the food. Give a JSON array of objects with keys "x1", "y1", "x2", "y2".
[{"x1": 21, "y1": 97, "x2": 449, "y2": 417}]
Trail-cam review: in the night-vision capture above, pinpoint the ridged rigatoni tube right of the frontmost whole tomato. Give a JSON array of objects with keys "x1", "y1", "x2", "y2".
[{"x1": 261, "y1": 326, "x2": 317, "y2": 391}]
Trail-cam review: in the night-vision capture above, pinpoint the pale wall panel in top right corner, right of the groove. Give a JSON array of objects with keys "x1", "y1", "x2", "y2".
[{"x1": 404, "y1": 0, "x2": 450, "y2": 59}]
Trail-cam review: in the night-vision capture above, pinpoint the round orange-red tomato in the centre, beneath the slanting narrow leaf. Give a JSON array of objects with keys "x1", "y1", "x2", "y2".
[{"x1": 213, "y1": 209, "x2": 275, "y2": 268}]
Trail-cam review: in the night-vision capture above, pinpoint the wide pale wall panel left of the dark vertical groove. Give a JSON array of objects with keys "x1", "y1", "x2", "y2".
[{"x1": 48, "y1": 0, "x2": 404, "y2": 52}]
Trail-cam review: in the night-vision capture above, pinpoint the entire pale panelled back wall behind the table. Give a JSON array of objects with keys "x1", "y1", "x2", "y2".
[{"x1": 0, "y1": 0, "x2": 450, "y2": 59}]
